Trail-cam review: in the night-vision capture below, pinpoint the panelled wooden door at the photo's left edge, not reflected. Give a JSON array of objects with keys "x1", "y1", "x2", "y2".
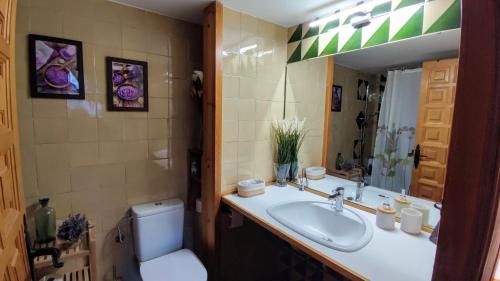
[{"x1": 0, "y1": 0, "x2": 30, "y2": 281}]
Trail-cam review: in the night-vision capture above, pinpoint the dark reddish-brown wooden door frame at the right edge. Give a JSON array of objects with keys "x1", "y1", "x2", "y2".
[{"x1": 433, "y1": 0, "x2": 500, "y2": 281}]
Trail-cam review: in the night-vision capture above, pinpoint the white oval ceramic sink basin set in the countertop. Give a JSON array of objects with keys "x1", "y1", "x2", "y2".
[{"x1": 267, "y1": 201, "x2": 373, "y2": 252}]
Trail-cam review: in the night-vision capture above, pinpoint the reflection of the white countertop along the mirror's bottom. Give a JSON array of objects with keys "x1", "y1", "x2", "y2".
[{"x1": 307, "y1": 175, "x2": 441, "y2": 228}]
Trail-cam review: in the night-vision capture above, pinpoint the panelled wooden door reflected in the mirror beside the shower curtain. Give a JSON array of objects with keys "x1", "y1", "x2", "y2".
[{"x1": 412, "y1": 59, "x2": 458, "y2": 201}]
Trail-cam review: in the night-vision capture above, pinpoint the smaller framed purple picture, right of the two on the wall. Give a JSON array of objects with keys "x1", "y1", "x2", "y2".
[{"x1": 106, "y1": 57, "x2": 148, "y2": 111}]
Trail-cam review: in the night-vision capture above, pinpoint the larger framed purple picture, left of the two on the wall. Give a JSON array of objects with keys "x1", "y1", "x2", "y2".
[{"x1": 28, "y1": 34, "x2": 85, "y2": 99}]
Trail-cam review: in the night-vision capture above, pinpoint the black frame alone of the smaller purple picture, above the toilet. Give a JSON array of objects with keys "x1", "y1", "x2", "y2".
[{"x1": 106, "y1": 57, "x2": 149, "y2": 112}]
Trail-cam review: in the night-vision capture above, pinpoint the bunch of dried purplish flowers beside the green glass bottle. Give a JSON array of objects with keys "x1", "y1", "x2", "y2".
[{"x1": 57, "y1": 214, "x2": 89, "y2": 248}]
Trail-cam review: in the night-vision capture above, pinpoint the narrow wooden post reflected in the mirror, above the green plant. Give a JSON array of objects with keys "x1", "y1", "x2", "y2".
[{"x1": 321, "y1": 56, "x2": 335, "y2": 168}]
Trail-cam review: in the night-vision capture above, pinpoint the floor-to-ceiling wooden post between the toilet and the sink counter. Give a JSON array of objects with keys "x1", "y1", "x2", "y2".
[{"x1": 201, "y1": 2, "x2": 223, "y2": 280}]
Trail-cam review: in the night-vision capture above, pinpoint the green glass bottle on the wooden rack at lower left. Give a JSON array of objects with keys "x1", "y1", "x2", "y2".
[{"x1": 35, "y1": 198, "x2": 56, "y2": 243}]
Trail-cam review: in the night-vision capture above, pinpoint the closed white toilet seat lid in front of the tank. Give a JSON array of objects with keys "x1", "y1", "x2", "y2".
[{"x1": 141, "y1": 249, "x2": 207, "y2": 281}]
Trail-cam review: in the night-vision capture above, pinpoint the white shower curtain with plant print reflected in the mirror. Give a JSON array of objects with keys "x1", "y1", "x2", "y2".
[{"x1": 371, "y1": 68, "x2": 422, "y2": 193}]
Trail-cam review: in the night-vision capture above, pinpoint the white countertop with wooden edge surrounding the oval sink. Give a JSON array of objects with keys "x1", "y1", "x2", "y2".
[{"x1": 223, "y1": 186, "x2": 436, "y2": 281}]
